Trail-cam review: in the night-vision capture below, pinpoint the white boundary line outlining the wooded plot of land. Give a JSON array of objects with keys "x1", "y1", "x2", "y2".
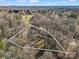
[{"x1": 8, "y1": 24, "x2": 67, "y2": 53}]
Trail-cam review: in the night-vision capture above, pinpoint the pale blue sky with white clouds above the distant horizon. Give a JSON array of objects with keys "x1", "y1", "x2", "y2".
[{"x1": 0, "y1": 0, "x2": 79, "y2": 6}]
